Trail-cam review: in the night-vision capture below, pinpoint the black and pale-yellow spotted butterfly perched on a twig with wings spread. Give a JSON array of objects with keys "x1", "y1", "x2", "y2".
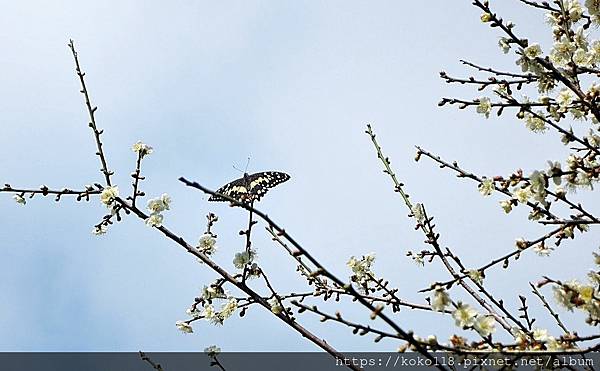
[{"x1": 208, "y1": 171, "x2": 290, "y2": 202}]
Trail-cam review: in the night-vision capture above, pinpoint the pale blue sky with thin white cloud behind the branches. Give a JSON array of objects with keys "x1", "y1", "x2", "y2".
[{"x1": 0, "y1": 0, "x2": 598, "y2": 351}]
